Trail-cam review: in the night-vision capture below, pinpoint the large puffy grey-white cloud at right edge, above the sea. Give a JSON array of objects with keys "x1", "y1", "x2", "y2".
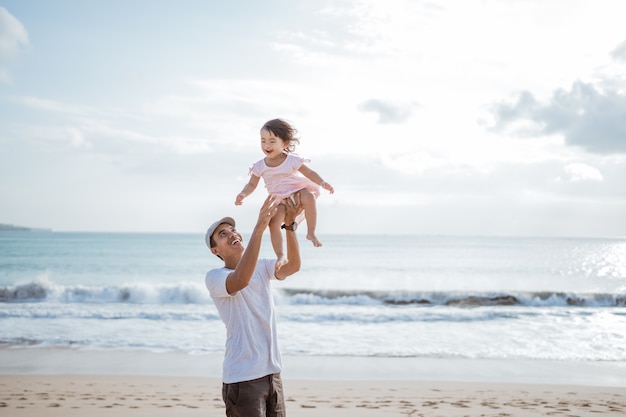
[{"x1": 493, "y1": 81, "x2": 626, "y2": 154}]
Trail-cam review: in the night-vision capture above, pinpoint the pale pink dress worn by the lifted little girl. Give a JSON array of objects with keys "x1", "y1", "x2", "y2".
[{"x1": 250, "y1": 154, "x2": 320, "y2": 199}]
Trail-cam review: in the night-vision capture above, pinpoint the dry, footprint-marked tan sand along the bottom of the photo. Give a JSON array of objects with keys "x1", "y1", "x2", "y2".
[{"x1": 0, "y1": 375, "x2": 626, "y2": 417}]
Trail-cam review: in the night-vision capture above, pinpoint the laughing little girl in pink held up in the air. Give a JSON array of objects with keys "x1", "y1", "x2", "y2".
[{"x1": 235, "y1": 119, "x2": 335, "y2": 268}]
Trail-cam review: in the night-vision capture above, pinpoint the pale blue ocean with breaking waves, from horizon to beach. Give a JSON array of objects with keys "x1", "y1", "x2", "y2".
[{"x1": 0, "y1": 231, "x2": 626, "y2": 366}]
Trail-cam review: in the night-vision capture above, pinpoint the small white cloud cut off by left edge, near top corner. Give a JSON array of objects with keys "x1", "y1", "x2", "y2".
[{"x1": 0, "y1": 6, "x2": 28, "y2": 83}]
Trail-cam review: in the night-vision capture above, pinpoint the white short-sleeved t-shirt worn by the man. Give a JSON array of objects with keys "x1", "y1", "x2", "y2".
[{"x1": 205, "y1": 259, "x2": 282, "y2": 384}]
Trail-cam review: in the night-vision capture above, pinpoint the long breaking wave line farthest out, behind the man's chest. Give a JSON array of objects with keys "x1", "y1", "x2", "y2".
[{"x1": 0, "y1": 279, "x2": 626, "y2": 308}]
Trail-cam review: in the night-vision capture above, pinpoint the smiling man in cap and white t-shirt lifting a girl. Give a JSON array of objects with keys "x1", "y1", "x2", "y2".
[{"x1": 205, "y1": 195, "x2": 302, "y2": 417}]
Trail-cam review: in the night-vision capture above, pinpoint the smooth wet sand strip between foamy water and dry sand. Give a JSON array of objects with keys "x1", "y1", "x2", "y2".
[{"x1": 0, "y1": 346, "x2": 626, "y2": 388}]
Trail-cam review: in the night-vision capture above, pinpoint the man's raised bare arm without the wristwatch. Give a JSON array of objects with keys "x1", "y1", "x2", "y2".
[{"x1": 226, "y1": 196, "x2": 277, "y2": 294}]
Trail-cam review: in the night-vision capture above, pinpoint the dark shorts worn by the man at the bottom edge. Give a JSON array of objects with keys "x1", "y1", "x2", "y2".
[{"x1": 222, "y1": 374, "x2": 286, "y2": 417}]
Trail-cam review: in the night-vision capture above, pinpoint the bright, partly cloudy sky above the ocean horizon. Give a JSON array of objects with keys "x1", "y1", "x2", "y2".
[{"x1": 0, "y1": 0, "x2": 626, "y2": 236}]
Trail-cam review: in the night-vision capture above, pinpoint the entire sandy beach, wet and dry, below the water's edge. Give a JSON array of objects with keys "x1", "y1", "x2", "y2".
[{"x1": 0, "y1": 349, "x2": 626, "y2": 417}]
